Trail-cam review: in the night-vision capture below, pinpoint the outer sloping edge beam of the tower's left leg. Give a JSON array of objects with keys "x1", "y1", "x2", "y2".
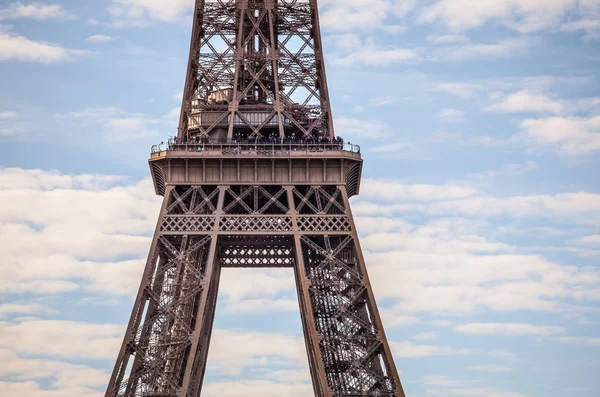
[{"x1": 105, "y1": 186, "x2": 173, "y2": 397}]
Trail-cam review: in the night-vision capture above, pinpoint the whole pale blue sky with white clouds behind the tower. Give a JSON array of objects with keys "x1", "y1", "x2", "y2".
[{"x1": 0, "y1": 0, "x2": 600, "y2": 397}]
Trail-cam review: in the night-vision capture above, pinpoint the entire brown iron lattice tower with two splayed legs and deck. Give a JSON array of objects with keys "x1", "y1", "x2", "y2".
[{"x1": 106, "y1": 0, "x2": 404, "y2": 397}]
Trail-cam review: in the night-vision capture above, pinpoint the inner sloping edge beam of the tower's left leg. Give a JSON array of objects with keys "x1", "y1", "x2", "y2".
[{"x1": 177, "y1": 186, "x2": 226, "y2": 397}]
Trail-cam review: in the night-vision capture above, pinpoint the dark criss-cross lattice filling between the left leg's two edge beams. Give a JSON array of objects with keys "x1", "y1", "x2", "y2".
[{"x1": 113, "y1": 235, "x2": 211, "y2": 397}]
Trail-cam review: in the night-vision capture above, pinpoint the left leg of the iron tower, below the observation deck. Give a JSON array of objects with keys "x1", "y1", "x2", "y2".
[{"x1": 105, "y1": 186, "x2": 223, "y2": 397}]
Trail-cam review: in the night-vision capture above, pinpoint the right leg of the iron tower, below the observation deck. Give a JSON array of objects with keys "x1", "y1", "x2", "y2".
[{"x1": 288, "y1": 187, "x2": 404, "y2": 397}]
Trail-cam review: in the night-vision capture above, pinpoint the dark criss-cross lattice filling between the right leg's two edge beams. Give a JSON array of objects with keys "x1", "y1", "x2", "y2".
[{"x1": 301, "y1": 236, "x2": 399, "y2": 397}]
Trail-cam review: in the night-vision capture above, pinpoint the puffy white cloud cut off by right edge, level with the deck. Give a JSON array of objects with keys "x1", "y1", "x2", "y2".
[{"x1": 513, "y1": 116, "x2": 600, "y2": 156}]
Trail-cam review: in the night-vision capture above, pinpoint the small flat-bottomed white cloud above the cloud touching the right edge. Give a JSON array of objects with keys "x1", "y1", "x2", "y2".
[{"x1": 486, "y1": 89, "x2": 565, "y2": 114}]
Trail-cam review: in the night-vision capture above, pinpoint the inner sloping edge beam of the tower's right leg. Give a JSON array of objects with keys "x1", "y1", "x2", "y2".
[{"x1": 285, "y1": 186, "x2": 331, "y2": 397}]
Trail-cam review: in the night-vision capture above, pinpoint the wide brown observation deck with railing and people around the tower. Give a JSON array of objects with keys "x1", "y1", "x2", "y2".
[{"x1": 148, "y1": 141, "x2": 363, "y2": 197}]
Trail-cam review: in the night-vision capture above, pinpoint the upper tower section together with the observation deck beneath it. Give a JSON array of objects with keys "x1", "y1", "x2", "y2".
[{"x1": 149, "y1": 0, "x2": 362, "y2": 196}]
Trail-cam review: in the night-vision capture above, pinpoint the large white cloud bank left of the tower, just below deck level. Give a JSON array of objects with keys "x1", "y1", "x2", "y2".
[{"x1": 0, "y1": 168, "x2": 160, "y2": 295}]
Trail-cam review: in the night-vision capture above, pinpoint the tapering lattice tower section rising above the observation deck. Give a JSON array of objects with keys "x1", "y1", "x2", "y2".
[{"x1": 180, "y1": 0, "x2": 333, "y2": 140}]
